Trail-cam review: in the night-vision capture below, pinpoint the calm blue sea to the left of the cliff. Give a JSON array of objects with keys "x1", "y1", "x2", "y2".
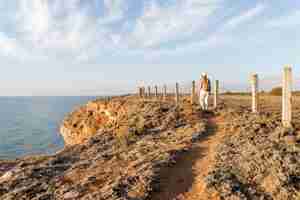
[{"x1": 0, "y1": 97, "x2": 95, "y2": 159}]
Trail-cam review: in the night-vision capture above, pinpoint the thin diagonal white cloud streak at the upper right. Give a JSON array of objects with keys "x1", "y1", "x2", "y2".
[{"x1": 224, "y1": 3, "x2": 265, "y2": 29}]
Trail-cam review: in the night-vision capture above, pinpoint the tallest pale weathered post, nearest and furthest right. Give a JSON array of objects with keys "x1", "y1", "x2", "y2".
[{"x1": 282, "y1": 65, "x2": 292, "y2": 128}]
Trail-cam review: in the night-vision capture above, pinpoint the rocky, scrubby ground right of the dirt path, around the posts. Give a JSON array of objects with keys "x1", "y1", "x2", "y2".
[{"x1": 206, "y1": 97, "x2": 300, "y2": 200}]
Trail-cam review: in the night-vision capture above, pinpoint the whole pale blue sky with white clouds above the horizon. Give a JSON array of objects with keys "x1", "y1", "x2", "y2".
[{"x1": 0, "y1": 0, "x2": 300, "y2": 96}]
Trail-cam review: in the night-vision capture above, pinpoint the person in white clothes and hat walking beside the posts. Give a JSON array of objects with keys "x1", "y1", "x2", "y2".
[{"x1": 199, "y1": 73, "x2": 211, "y2": 111}]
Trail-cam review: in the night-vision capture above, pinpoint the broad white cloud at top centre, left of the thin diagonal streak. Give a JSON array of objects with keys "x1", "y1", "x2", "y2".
[{"x1": 131, "y1": 0, "x2": 221, "y2": 47}]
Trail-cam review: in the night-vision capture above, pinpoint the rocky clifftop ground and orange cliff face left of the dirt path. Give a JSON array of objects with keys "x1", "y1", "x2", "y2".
[{"x1": 0, "y1": 97, "x2": 206, "y2": 200}]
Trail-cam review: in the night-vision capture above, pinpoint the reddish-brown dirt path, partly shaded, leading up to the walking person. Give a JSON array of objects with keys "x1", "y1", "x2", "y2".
[{"x1": 152, "y1": 112, "x2": 225, "y2": 200}]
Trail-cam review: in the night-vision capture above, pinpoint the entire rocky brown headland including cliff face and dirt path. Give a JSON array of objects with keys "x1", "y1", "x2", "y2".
[{"x1": 0, "y1": 95, "x2": 300, "y2": 200}]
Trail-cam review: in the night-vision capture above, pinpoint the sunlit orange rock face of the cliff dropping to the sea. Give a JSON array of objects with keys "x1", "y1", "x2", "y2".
[{"x1": 60, "y1": 98, "x2": 127, "y2": 145}]
